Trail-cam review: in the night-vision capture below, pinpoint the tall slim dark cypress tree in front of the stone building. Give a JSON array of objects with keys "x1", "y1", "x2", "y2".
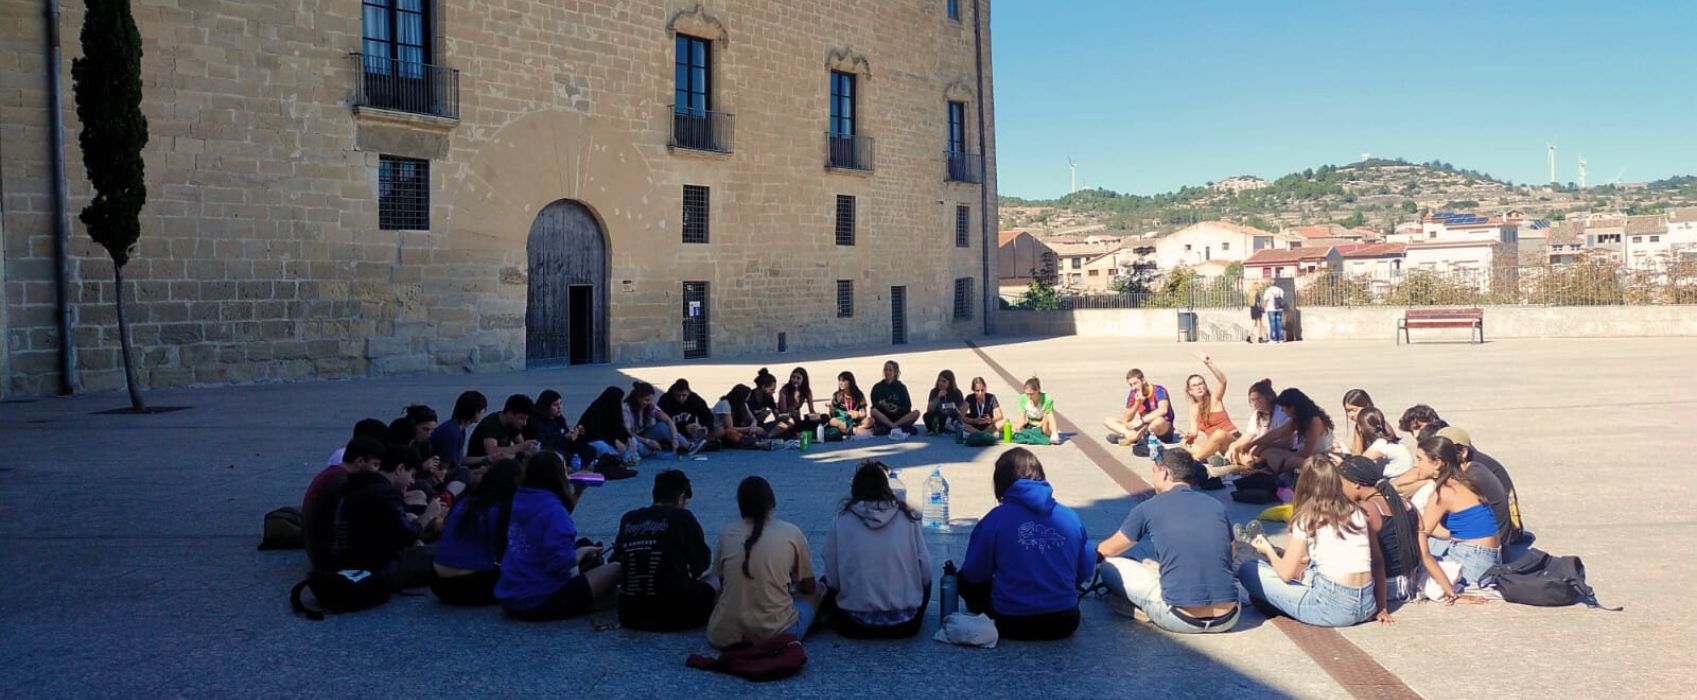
[{"x1": 72, "y1": 0, "x2": 148, "y2": 411}]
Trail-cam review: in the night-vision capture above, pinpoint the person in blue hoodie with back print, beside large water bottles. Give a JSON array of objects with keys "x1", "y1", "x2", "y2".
[{"x1": 961, "y1": 447, "x2": 1096, "y2": 639}]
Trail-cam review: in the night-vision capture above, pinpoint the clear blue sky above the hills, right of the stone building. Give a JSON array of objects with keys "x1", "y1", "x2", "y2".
[{"x1": 991, "y1": 0, "x2": 1697, "y2": 197}]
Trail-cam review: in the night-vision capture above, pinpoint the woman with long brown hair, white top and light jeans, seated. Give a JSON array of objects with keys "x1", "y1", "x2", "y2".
[{"x1": 1237, "y1": 454, "x2": 1393, "y2": 627}]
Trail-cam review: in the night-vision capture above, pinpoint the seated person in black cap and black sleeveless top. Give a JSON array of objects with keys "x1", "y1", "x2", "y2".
[{"x1": 1337, "y1": 455, "x2": 1420, "y2": 610}]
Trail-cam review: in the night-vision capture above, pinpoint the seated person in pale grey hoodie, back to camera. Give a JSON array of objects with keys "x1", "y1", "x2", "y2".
[{"x1": 823, "y1": 460, "x2": 932, "y2": 639}]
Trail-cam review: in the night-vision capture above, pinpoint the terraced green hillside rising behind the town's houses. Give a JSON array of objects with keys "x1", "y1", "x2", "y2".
[{"x1": 1001, "y1": 160, "x2": 1697, "y2": 231}]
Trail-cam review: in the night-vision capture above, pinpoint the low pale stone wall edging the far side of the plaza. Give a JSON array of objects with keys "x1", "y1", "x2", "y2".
[{"x1": 996, "y1": 306, "x2": 1697, "y2": 342}]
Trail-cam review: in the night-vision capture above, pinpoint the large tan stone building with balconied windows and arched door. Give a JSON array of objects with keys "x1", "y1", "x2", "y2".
[{"x1": 0, "y1": 0, "x2": 998, "y2": 396}]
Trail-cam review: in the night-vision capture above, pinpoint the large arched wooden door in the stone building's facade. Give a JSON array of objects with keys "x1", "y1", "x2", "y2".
[{"x1": 524, "y1": 199, "x2": 608, "y2": 367}]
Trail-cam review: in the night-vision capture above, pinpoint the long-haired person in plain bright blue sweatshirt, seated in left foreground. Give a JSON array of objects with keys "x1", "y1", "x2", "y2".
[{"x1": 496, "y1": 452, "x2": 621, "y2": 622}]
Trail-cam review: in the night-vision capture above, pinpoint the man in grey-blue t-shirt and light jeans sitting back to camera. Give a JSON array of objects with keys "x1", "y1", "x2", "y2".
[{"x1": 1096, "y1": 447, "x2": 1239, "y2": 634}]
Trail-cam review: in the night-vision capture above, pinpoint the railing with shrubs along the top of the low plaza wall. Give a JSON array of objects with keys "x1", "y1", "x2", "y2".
[{"x1": 1008, "y1": 263, "x2": 1697, "y2": 311}]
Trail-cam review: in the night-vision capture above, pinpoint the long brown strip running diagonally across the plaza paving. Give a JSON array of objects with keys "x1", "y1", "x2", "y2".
[{"x1": 966, "y1": 340, "x2": 1420, "y2": 700}]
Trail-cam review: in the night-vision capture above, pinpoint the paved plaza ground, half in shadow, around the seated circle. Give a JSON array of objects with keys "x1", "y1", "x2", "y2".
[{"x1": 0, "y1": 338, "x2": 1697, "y2": 698}]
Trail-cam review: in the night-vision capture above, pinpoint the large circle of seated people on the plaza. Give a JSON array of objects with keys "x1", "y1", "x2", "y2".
[{"x1": 302, "y1": 357, "x2": 1529, "y2": 647}]
